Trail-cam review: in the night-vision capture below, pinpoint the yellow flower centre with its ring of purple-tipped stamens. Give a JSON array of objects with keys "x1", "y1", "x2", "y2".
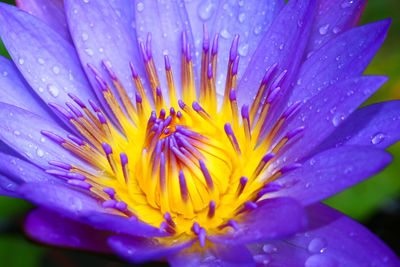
[{"x1": 42, "y1": 26, "x2": 302, "y2": 246}]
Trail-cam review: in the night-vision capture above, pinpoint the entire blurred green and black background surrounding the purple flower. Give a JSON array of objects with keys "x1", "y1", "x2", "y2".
[{"x1": 0, "y1": 0, "x2": 400, "y2": 267}]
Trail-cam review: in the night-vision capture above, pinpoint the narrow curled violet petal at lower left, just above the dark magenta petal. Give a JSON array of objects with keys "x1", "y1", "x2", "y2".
[{"x1": 18, "y1": 183, "x2": 167, "y2": 237}]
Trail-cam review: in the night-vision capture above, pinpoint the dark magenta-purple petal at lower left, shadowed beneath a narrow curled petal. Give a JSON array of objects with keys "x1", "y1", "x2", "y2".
[{"x1": 24, "y1": 209, "x2": 111, "y2": 253}]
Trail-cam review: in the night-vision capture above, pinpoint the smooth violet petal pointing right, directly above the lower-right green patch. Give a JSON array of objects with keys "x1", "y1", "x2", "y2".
[{"x1": 266, "y1": 146, "x2": 392, "y2": 205}]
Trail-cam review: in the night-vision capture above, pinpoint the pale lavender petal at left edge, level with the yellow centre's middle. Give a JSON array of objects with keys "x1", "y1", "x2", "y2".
[{"x1": 0, "y1": 103, "x2": 87, "y2": 168}]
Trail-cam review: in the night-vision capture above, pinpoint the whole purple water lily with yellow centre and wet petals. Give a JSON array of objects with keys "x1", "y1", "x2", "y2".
[{"x1": 0, "y1": 0, "x2": 400, "y2": 266}]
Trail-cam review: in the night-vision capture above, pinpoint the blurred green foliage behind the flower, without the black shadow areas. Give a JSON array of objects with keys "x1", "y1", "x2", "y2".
[{"x1": 0, "y1": 0, "x2": 400, "y2": 267}]
